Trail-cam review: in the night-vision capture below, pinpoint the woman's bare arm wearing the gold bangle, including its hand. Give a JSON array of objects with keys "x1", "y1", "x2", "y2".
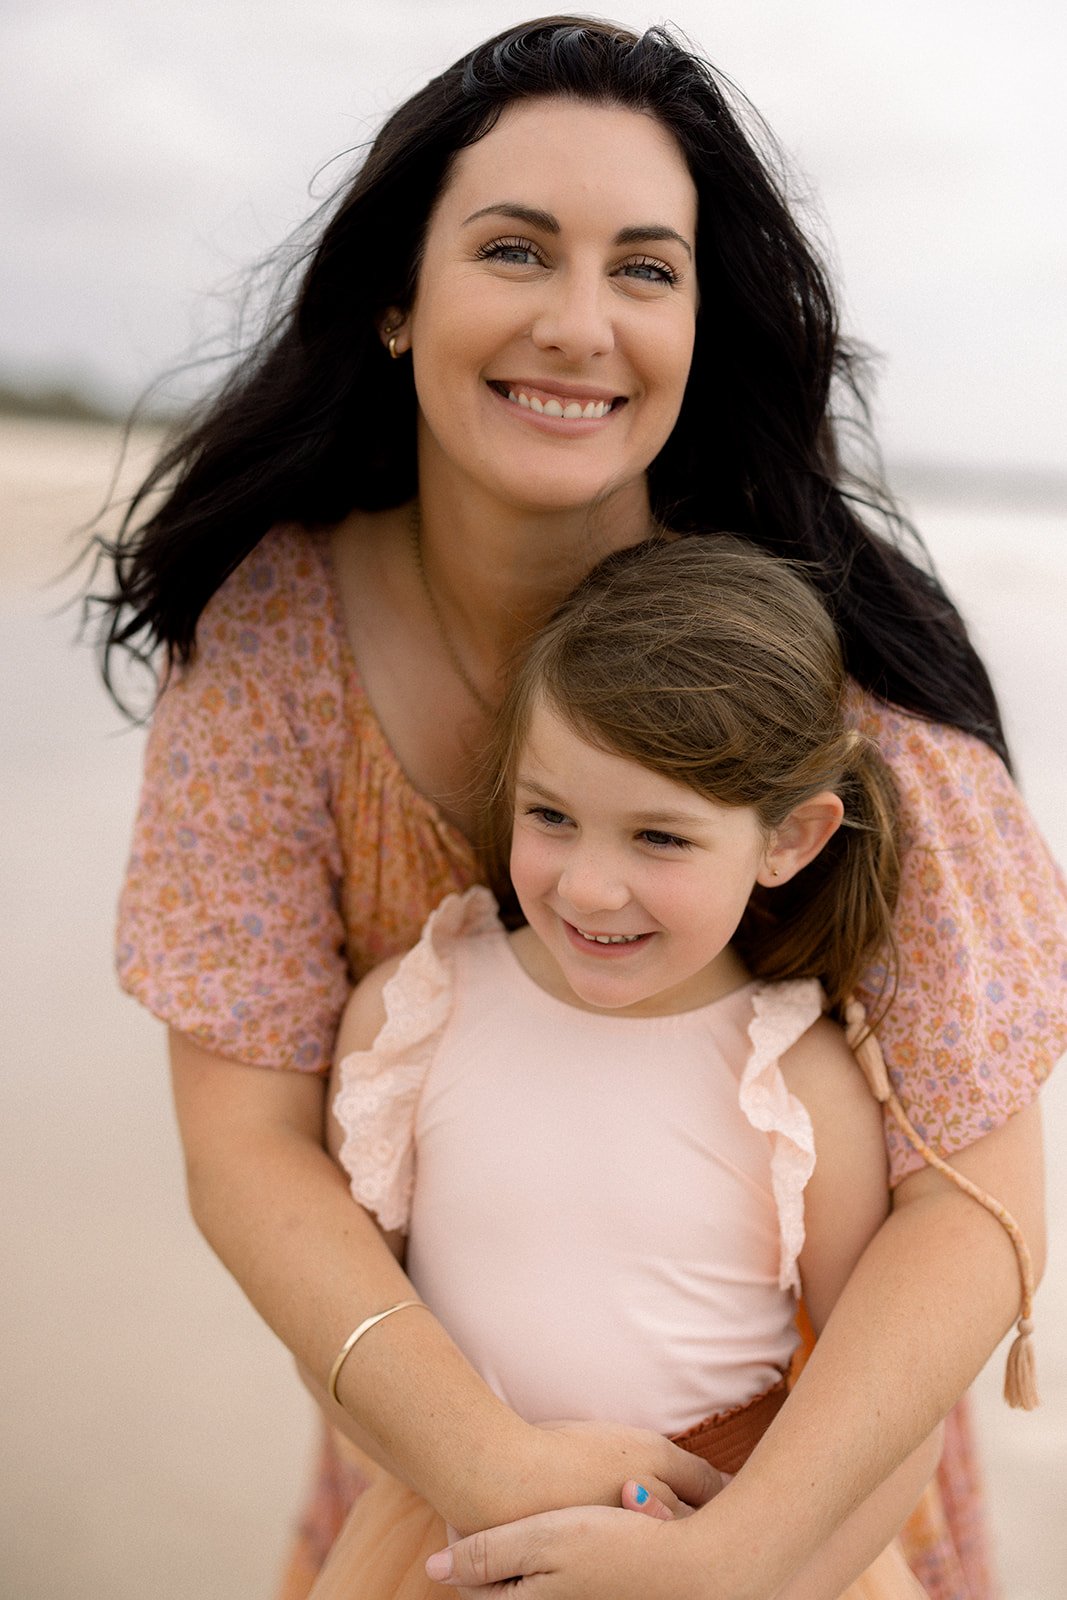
[{"x1": 171, "y1": 1032, "x2": 718, "y2": 1531}]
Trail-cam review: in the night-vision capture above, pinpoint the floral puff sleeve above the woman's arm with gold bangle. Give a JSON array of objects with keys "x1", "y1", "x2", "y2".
[{"x1": 117, "y1": 530, "x2": 349, "y2": 1072}]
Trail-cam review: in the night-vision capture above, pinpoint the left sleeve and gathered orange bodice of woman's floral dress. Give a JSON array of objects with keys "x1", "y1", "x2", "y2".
[{"x1": 117, "y1": 528, "x2": 478, "y2": 1072}]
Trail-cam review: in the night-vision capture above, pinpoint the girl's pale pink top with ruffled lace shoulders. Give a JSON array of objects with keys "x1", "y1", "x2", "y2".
[{"x1": 334, "y1": 888, "x2": 822, "y2": 1432}]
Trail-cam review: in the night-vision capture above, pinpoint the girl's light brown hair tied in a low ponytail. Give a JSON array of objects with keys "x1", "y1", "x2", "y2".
[{"x1": 488, "y1": 534, "x2": 899, "y2": 1010}]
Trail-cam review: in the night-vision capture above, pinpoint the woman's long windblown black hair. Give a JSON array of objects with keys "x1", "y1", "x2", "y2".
[{"x1": 88, "y1": 16, "x2": 1006, "y2": 758}]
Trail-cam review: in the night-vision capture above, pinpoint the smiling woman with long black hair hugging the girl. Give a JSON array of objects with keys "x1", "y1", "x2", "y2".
[{"x1": 95, "y1": 19, "x2": 1064, "y2": 1597}]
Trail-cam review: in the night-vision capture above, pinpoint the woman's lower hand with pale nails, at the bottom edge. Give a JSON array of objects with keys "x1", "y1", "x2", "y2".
[{"x1": 426, "y1": 1506, "x2": 715, "y2": 1600}]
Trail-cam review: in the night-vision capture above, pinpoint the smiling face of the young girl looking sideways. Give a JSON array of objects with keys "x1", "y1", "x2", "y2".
[{"x1": 512, "y1": 704, "x2": 771, "y2": 1016}]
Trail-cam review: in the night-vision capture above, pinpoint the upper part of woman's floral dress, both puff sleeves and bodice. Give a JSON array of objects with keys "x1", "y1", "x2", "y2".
[{"x1": 118, "y1": 528, "x2": 1067, "y2": 1181}]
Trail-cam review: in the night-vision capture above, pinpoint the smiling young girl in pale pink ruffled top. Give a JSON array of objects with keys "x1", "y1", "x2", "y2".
[{"x1": 314, "y1": 539, "x2": 1036, "y2": 1600}]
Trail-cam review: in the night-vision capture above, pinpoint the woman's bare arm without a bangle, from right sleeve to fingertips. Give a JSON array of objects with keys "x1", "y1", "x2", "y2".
[{"x1": 438, "y1": 1104, "x2": 1045, "y2": 1600}]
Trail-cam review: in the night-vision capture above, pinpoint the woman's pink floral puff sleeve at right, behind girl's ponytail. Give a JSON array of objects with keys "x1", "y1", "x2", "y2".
[{"x1": 856, "y1": 696, "x2": 1067, "y2": 1182}]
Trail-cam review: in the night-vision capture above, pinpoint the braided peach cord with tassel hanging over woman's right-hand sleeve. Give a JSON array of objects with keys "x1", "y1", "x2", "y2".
[{"x1": 845, "y1": 995, "x2": 1040, "y2": 1411}]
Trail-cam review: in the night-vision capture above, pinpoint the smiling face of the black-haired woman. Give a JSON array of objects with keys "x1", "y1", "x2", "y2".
[{"x1": 398, "y1": 99, "x2": 697, "y2": 510}]
